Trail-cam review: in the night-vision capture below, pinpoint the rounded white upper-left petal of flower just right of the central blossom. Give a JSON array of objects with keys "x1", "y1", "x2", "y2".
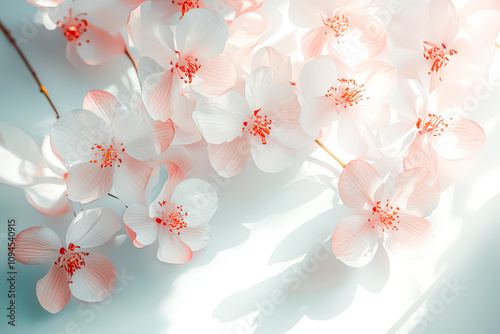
[{"x1": 299, "y1": 58, "x2": 339, "y2": 97}]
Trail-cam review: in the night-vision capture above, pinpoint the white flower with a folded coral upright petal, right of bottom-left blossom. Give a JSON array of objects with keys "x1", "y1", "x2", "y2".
[{"x1": 123, "y1": 172, "x2": 217, "y2": 263}]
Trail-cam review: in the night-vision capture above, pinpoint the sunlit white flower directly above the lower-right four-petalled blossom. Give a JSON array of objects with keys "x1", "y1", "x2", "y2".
[{"x1": 300, "y1": 58, "x2": 396, "y2": 157}]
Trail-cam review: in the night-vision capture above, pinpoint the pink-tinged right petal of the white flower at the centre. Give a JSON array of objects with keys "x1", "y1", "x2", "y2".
[{"x1": 268, "y1": 95, "x2": 314, "y2": 148}]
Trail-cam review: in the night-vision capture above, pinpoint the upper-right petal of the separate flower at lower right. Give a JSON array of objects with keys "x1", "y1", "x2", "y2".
[{"x1": 389, "y1": 168, "x2": 440, "y2": 217}]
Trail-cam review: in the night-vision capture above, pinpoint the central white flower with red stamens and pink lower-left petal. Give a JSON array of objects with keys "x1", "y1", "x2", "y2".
[{"x1": 193, "y1": 67, "x2": 312, "y2": 177}]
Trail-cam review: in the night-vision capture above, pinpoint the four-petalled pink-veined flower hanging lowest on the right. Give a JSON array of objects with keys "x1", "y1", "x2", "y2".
[{"x1": 332, "y1": 160, "x2": 439, "y2": 267}]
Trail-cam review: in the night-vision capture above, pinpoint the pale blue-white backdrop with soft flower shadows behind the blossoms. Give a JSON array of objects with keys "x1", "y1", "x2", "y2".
[{"x1": 0, "y1": 0, "x2": 500, "y2": 334}]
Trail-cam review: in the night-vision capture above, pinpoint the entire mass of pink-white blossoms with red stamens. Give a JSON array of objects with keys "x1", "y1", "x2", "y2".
[{"x1": 0, "y1": 0, "x2": 500, "y2": 313}]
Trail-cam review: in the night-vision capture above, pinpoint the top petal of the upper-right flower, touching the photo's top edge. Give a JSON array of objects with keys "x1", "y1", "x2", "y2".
[{"x1": 429, "y1": 0, "x2": 458, "y2": 45}]
